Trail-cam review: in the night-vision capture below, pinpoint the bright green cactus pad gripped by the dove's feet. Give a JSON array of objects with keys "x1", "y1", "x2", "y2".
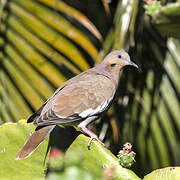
[{"x1": 65, "y1": 135, "x2": 139, "y2": 179}]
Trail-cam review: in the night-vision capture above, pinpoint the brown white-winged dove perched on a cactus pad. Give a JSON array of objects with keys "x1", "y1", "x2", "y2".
[{"x1": 16, "y1": 50, "x2": 138, "y2": 159}]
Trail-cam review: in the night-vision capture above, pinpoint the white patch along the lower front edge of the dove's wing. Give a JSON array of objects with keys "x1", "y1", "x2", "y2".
[{"x1": 79, "y1": 101, "x2": 108, "y2": 118}]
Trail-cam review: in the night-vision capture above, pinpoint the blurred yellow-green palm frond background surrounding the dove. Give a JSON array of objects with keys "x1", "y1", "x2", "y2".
[{"x1": 0, "y1": 0, "x2": 180, "y2": 177}]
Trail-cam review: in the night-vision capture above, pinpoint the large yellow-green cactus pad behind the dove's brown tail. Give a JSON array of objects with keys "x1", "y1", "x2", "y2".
[{"x1": 0, "y1": 120, "x2": 48, "y2": 180}]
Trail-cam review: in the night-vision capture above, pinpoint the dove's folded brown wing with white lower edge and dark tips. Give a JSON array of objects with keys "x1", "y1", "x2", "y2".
[{"x1": 34, "y1": 74, "x2": 116, "y2": 126}]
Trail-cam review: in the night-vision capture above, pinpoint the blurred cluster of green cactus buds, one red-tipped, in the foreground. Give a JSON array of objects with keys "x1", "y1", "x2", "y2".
[{"x1": 46, "y1": 147, "x2": 99, "y2": 180}]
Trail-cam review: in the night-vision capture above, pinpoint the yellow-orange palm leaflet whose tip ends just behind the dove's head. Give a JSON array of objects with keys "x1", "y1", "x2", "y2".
[{"x1": 15, "y1": 0, "x2": 99, "y2": 60}]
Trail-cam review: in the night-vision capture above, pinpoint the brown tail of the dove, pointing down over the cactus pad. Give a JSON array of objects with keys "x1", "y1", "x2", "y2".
[{"x1": 16, "y1": 125, "x2": 55, "y2": 160}]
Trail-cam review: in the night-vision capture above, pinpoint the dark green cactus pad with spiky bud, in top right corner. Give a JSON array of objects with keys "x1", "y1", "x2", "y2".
[{"x1": 145, "y1": 1, "x2": 180, "y2": 38}]
